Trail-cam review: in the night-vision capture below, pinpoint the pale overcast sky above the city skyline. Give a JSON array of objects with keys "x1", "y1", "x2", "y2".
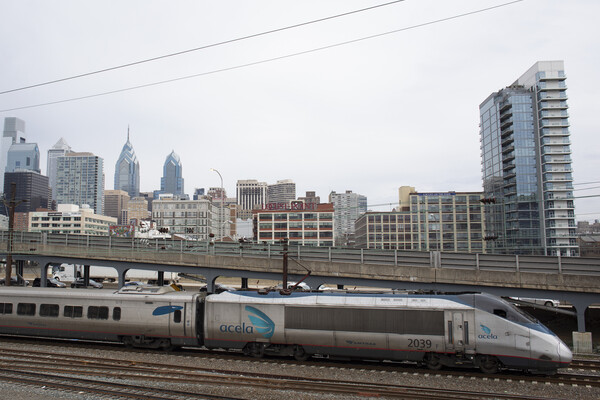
[{"x1": 0, "y1": 0, "x2": 600, "y2": 220}]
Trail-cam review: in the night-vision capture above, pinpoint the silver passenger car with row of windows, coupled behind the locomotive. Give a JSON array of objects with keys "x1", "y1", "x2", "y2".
[{"x1": 0, "y1": 287, "x2": 199, "y2": 348}]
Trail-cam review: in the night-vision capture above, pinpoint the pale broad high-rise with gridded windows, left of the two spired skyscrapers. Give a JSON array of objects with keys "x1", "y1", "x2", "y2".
[{"x1": 56, "y1": 153, "x2": 104, "y2": 215}]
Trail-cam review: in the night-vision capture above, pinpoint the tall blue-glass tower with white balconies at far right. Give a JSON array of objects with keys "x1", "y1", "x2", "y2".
[{"x1": 479, "y1": 61, "x2": 579, "y2": 256}]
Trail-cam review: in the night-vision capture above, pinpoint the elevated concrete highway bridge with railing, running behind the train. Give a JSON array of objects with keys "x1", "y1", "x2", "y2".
[{"x1": 0, "y1": 231, "x2": 600, "y2": 332}]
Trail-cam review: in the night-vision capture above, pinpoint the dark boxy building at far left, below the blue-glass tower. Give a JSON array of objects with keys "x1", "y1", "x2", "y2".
[{"x1": 0, "y1": 170, "x2": 50, "y2": 215}]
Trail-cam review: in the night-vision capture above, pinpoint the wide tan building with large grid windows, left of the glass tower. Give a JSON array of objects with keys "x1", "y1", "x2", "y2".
[{"x1": 355, "y1": 186, "x2": 486, "y2": 253}]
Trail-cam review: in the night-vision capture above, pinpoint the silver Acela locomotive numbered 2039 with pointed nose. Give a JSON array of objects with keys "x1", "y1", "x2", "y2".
[{"x1": 203, "y1": 292, "x2": 572, "y2": 373}]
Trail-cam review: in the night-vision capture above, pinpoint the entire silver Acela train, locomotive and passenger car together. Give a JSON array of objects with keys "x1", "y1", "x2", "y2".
[{"x1": 0, "y1": 286, "x2": 572, "y2": 374}]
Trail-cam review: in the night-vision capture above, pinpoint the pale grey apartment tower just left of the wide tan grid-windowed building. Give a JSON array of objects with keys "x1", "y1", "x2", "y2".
[{"x1": 329, "y1": 190, "x2": 367, "y2": 246}]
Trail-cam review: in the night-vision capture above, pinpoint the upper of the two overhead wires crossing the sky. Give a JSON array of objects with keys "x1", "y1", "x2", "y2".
[{"x1": 0, "y1": 0, "x2": 406, "y2": 94}]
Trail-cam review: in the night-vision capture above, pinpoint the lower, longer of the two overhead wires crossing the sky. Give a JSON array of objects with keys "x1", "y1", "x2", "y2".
[{"x1": 0, "y1": 0, "x2": 524, "y2": 112}]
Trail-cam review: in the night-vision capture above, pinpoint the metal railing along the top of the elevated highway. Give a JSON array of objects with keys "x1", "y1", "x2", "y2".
[{"x1": 0, "y1": 230, "x2": 600, "y2": 276}]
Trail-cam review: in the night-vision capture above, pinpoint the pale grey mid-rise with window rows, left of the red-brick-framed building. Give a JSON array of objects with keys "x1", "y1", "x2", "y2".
[{"x1": 152, "y1": 195, "x2": 215, "y2": 240}]
